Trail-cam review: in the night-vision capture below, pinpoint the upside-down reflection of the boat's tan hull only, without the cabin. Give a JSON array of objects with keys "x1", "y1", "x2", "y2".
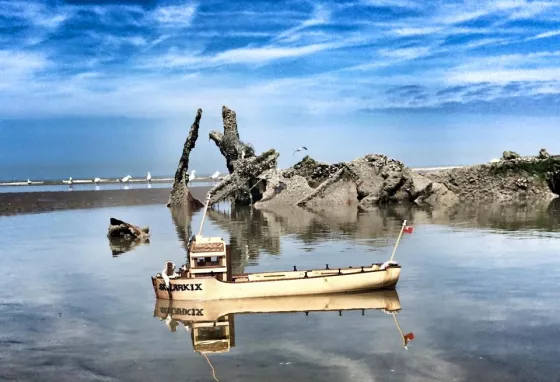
[{"x1": 154, "y1": 289, "x2": 401, "y2": 322}]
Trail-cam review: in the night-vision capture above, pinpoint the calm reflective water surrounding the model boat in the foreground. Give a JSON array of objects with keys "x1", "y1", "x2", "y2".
[{"x1": 0, "y1": 201, "x2": 560, "y2": 381}]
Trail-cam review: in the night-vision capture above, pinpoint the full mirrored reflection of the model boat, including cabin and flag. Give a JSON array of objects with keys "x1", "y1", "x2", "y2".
[{"x1": 154, "y1": 290, "x2": 414, "y2": 380}]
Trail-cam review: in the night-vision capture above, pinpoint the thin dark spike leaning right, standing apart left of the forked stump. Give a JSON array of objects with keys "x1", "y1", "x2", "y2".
[{"x1": 167, "y1": 109, "x2": 206, "y2": 207}]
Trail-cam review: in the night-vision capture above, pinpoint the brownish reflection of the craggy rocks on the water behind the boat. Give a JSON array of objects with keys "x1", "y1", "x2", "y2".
[{"x1": 209, "y1": 199, "x2": 560, "y2": 256}]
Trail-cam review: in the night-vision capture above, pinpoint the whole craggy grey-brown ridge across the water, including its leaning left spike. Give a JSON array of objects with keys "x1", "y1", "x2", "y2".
[{"x1": 169, "y1": 106, "x2": 560, "y2": 209}]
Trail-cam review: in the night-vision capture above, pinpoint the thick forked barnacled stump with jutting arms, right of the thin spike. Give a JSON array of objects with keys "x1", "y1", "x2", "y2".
[{"x1": 209, "y1": 106, "x2": 280, "y2": 205}]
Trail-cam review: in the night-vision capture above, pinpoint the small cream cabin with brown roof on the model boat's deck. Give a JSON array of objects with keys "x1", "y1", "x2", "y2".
[{"x1": 189, "y1": 235, "x2": 232, "y2": 281}]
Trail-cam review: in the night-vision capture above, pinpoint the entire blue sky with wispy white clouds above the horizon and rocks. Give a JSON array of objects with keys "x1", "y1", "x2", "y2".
[{"x1": 0, "y1": 0, "x2": 560, "y2": 179}]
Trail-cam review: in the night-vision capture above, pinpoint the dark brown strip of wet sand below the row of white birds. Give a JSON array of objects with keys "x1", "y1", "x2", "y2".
[{"x1": 0, "y1": 187, "x2": 210, "y2": 216}]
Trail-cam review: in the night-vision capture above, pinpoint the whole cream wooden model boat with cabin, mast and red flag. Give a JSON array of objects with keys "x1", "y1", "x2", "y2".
[{"x1": 152, "y1": 195, "x2": 412, "y2": 300}]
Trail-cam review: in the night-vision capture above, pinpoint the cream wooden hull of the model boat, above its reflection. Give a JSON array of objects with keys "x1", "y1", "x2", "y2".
[{"x1": 152, "y1": 265, "x2": 401, "y2": 300}]
